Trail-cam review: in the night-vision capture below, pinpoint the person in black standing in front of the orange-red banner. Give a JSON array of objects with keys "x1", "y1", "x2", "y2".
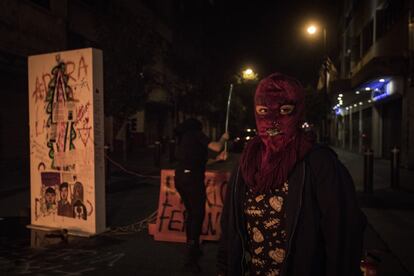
[{"x1": 175, "y1": 118, "x2": 229, "y2": 272}]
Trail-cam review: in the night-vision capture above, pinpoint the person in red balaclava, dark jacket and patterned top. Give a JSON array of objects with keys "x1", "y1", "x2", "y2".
[{"x1": 217, "y1": 73, "x2": 366, "y2": 276}]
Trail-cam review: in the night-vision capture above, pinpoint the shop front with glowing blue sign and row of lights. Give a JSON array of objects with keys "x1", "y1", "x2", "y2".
[{"x1": 334, "y1": 76, "x2": 404, "y2": 159}]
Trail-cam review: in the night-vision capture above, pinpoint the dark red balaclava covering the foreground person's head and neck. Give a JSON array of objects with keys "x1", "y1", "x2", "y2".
[{"x1": 241, "y1": 73, "x2": 314, "y2": 192}]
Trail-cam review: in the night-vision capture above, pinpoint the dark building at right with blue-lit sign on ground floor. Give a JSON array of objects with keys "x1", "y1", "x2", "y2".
[{"x1": 330, "y1": 0, "x2": 414, "y2": 168}]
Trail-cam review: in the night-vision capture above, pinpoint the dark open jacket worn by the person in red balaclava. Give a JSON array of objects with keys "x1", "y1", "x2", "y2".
[{"x1": 217, "y1": 146, "x2": 366, "y2": 276}]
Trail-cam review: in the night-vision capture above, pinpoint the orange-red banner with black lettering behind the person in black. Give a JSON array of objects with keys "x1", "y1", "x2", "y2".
[{"x1": 148, "y1": 170, "x2": 230, "y2": 242}]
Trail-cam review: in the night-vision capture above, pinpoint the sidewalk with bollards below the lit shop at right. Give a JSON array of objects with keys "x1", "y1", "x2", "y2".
[{"x1": 335, "y1": 148, "x2": 414, "y2": 275}]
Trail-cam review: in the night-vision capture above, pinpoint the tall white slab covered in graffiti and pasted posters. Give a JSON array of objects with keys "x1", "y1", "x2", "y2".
[{"x1": 28, "y1": 48, "x2": 105, "y2": 235}]
